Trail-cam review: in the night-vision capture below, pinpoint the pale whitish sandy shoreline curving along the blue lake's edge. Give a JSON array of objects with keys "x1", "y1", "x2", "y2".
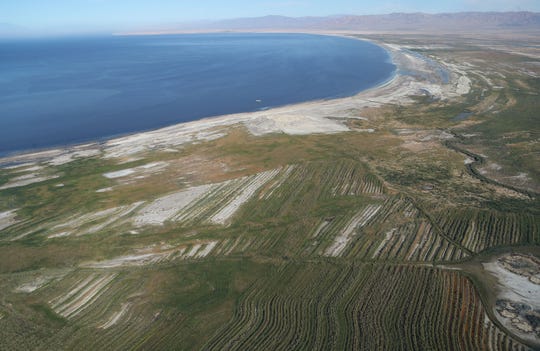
[{"x1": 0, "y1": 33, "x2": 464, "y2": 167}]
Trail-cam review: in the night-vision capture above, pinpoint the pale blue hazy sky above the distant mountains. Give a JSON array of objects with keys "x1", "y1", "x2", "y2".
[{"x1": 0, "y1": 0, "x2": 540, "y2": 33}]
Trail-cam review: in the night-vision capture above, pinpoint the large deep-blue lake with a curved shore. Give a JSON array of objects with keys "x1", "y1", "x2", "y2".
[{"x1": 0, "y1": 34, "x2": 395, "y2": 155}]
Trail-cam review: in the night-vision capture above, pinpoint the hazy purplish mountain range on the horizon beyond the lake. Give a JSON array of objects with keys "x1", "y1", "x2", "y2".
[{"x1": 185, "y1": 12, "x2": 540, "y2": 32}]
